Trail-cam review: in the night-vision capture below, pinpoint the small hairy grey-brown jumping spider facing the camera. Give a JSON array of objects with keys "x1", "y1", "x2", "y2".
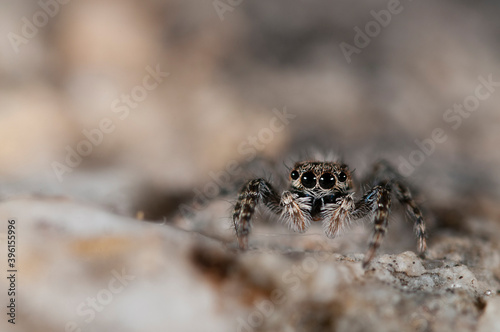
[{"x1": 233, "y1": 161, "x2": 426, "y2": 267}]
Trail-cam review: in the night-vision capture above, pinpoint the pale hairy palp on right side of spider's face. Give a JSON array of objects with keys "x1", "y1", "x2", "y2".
[{"x1": 321, "y1": 193, "x2": 356, "y2": 238}]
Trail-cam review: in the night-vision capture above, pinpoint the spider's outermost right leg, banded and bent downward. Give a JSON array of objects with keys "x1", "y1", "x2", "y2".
[{"x1": 374, "y1": 161, "x2": 427, "y2": 253}]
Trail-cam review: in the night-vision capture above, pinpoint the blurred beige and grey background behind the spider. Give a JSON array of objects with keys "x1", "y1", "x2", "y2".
[{"x1": 0, "y1": 0, "x2": 500, "y2": 327}]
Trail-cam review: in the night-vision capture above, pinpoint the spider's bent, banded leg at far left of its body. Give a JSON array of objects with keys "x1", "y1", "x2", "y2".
[{"x1": 233, "y1": 179, "x2": 280, "y2": 249}]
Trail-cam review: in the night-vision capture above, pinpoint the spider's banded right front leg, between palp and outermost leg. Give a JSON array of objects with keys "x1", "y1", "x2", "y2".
[{"x1": 363, "y1": 186, "x2": 391, "y2": 267}]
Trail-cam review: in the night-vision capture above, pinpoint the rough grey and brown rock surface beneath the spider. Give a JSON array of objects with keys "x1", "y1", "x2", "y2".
[{"x1": 0, "y1": 193, "x2": 500, "y2": 331}]
